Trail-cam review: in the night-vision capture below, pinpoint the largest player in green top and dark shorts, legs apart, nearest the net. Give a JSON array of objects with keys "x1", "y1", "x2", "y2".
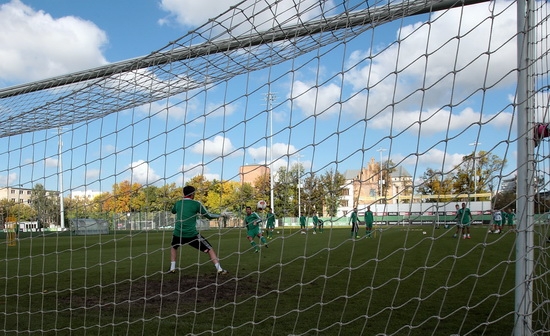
[{"x1": 168, "y1": 186, "x2": 227, "y2": 274}]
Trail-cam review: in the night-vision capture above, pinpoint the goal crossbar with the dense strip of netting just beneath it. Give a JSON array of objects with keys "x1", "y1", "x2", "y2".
[{"x1": 0, "y1": 0, "x2": 492, "y2": 137}]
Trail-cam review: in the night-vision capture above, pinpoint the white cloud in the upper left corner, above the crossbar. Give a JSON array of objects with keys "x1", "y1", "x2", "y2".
[{"x1": 0, "y1": 0, "x2": 107, "y2": 83}]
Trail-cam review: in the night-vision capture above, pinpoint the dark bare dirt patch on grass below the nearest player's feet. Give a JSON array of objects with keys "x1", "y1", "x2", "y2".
[{"x1": 58, "y1": 273, "x2": 271, "y2": 313}]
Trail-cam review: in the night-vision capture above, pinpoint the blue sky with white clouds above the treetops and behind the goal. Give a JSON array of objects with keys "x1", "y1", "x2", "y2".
[{"x1": 0, "y1": 0, "x2": 540, "y2": 191}]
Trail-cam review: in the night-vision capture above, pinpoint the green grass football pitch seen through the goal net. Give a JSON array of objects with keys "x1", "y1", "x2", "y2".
[{"x1": 0, "y1": 226, "x2": 540, "y2": 335}]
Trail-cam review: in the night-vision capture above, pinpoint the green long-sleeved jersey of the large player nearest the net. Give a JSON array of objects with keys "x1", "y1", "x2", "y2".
[{"x1": 172, "y1": 198, "x2": 220, "y2": 238}]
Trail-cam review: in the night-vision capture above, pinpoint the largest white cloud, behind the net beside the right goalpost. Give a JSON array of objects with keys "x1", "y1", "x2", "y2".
[{"x1": 291, "y1": 1, "x2": 516, "y2": 136}]
